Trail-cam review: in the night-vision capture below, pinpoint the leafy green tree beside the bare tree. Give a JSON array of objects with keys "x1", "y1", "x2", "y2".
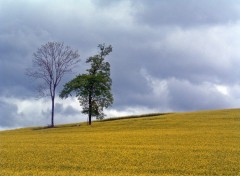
[{"x1": 60, "y1": 44, "x2": 113, "y2": 125}]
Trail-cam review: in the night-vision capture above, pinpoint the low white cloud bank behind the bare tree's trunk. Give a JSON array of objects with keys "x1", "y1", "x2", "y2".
[{"x1": 0, "y1": 98, "x2": 85, "y2": 130}]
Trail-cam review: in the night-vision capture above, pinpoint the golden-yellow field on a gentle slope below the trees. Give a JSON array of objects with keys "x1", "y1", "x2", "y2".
[{"x1": 0, "y1": 109, "x2": 240, "y2": 176}]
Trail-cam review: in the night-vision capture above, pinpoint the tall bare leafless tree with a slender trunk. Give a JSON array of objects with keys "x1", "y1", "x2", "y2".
[{"x1": 26, "y1": 42, "x2": 80, "y2": 127}]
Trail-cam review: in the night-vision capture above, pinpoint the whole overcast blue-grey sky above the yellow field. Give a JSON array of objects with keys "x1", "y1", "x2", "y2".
[{"x1": 0, "y1": 0, "x2": 240, "y2": 129}]
